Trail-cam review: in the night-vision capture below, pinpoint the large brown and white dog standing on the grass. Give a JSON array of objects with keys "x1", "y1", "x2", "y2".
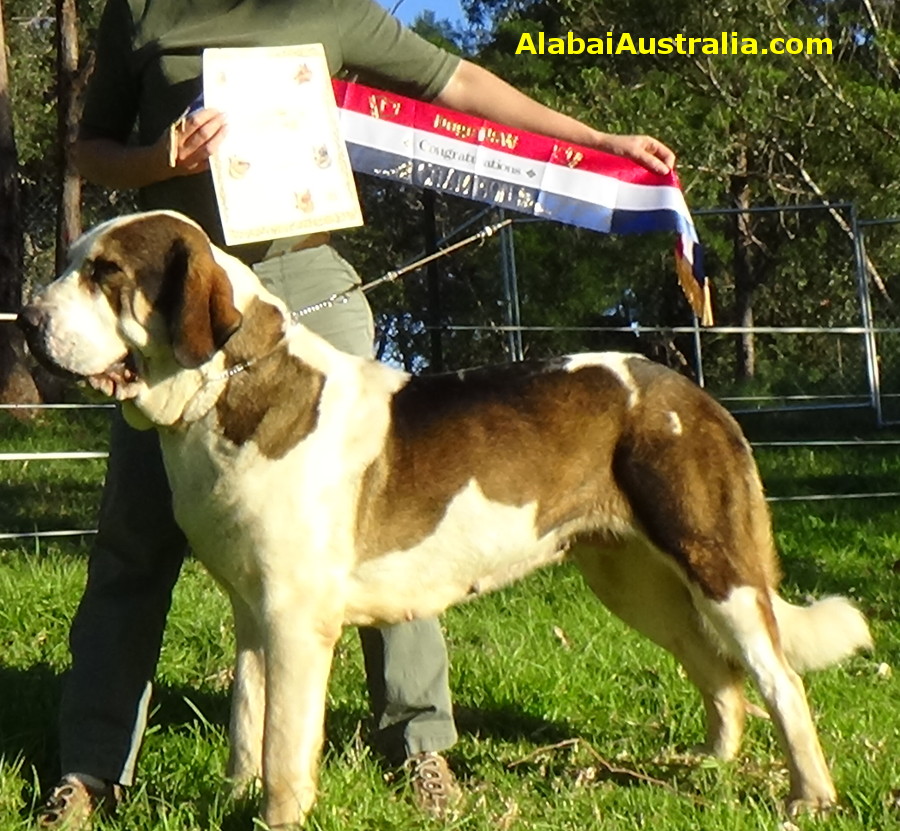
[{"x1": 20, "y1": 212, "x2": 870, "y2": 826}]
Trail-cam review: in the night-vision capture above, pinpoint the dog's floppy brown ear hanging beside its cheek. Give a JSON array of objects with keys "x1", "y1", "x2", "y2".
[{"x1": 159, "y1": 238, "x2": 242, "y2": 369}]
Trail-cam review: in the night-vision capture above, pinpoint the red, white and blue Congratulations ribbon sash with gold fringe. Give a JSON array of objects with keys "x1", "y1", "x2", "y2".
[{"x1": 334, "y1": 81, "x2": 712, "y2": 324}]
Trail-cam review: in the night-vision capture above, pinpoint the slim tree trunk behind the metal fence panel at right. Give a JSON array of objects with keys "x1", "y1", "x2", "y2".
[{"x1": 730, "y1": 147, "x2": 756, "y2": 381}]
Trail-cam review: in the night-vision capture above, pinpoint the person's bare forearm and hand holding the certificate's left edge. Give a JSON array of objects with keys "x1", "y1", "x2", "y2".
[{"x1": 73, "y1": 109, "x2": 225, "y2": 189}]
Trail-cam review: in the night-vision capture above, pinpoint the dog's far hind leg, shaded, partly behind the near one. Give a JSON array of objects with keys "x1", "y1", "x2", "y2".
[{"x1": 571, "y1": 540, "x2": 745, "y2": 759}]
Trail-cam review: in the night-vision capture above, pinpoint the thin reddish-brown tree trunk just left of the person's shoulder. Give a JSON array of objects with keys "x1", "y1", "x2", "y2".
[{"x1": 56, "y1": 0, "x2": 83, "y2": 274}]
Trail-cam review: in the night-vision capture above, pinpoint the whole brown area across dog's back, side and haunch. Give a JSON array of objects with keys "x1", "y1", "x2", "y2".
[{"x1": 358, "y1": 358, "x2": 778, "y2": 599}]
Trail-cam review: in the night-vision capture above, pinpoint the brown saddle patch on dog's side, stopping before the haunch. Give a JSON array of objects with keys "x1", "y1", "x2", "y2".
[{"x1": 360, "y1": 361, "x2": 627, "y2": 556}]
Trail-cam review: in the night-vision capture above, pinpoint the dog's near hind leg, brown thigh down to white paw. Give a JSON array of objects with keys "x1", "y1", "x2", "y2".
[{"x1": 613, "y1": 386, "x2": 836, "y2": 810}]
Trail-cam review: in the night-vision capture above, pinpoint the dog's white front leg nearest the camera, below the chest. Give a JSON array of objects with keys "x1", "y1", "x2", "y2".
[{"x1": 263, "y1": 590, "x2": 342, "y2": 828}]
